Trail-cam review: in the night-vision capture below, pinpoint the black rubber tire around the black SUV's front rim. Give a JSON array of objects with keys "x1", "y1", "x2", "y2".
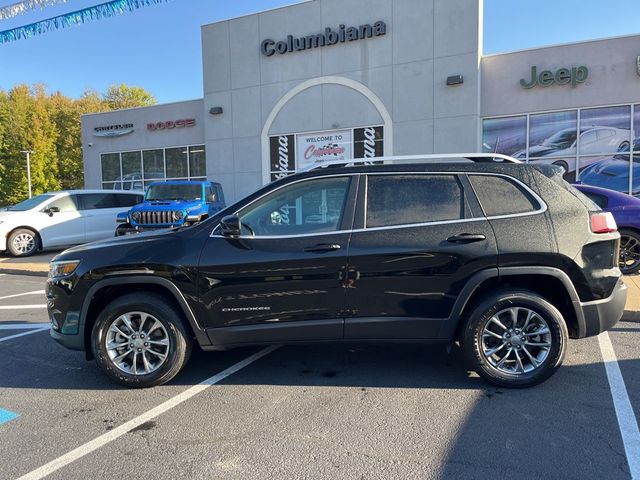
[{"x1": 91, "y1": 293, "x2": 193, "y2": 388}]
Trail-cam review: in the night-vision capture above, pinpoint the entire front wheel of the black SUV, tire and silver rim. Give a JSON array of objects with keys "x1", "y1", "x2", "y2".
[{"x1": 91, "y1": 293, "x2": 192, "y2": 388}]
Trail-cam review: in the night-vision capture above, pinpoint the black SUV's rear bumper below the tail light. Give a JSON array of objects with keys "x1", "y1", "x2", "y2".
[{"x1": 578, "y1": 277, "x2": 627, "y2": 338}]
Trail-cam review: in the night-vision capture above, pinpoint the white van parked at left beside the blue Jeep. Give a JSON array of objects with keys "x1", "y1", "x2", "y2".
[{"x1": 0, "y1": 190, "x2": 144, "y2": 257}]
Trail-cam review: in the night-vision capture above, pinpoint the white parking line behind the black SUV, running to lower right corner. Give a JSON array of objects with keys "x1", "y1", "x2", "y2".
[{"x1": 598, "y1": 332, "x2": 640, "y2": 480}]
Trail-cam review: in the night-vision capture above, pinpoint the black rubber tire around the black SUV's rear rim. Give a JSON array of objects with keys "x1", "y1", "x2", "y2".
[{"x1": 461, "y1": 289, "x2": 569, "y2": 388}]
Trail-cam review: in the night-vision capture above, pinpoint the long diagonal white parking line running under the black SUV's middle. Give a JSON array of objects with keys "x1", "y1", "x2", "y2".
[{"x1": 18, "y1": 345, "x2": 279, "y2": 480}]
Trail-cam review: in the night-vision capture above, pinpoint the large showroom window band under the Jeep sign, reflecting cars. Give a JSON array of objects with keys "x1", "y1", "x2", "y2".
[{"x1": 482, "y1": 105, "x2": 640, "y2": 195}]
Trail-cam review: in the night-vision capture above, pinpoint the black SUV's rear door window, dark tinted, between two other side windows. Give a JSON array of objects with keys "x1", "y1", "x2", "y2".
[{"x1": 366, "y1": 175, "x2": 468, "y2": 228}]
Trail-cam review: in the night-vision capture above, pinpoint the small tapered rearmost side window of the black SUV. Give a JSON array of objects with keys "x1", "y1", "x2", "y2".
[{"x1": 469, "y1": 175, "x2": 540, "y2": 217}]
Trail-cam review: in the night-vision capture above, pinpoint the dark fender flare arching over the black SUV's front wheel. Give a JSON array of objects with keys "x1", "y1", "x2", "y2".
[{"x1": 79, "y1": 275, "x2": 211, "y2": 352}]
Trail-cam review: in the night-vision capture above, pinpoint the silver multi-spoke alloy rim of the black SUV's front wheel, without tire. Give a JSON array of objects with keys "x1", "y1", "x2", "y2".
[{"x1": 105, "y1": 312, "x2": 171, "y2": 375}]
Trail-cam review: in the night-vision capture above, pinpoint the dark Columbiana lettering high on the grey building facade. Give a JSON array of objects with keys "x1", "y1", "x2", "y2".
[{"x1": 260, "y1": 21, "x2": 387, "y2": 57}]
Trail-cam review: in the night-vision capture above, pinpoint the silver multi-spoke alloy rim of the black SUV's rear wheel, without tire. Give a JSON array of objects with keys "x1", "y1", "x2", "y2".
[{"x1": 482, "y1": 307, "x2": 552, "y2": 375}]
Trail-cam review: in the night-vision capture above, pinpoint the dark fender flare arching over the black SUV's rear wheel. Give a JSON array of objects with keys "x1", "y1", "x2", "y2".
[{"x1": 440, "y1": 266, "x2": 587, "y2": 339}]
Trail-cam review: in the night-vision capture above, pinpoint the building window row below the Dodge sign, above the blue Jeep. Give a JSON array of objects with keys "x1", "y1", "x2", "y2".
[{"x1": 101, "y1": 145, "x2": 207, "y2": 191}]
